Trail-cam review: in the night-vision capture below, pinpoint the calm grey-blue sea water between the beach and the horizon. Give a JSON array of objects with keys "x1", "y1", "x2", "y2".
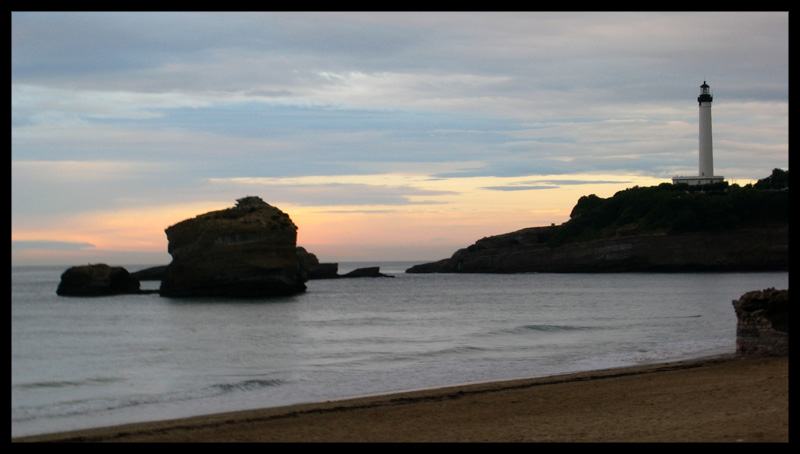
[{"x1": 11, "y1": 262, "x2": 789, "y2": 437}]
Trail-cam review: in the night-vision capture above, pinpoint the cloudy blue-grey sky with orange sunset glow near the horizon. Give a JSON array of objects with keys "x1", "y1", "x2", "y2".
[{"x1": 11, "y1": 12, "x2": 789, "y2": 265}]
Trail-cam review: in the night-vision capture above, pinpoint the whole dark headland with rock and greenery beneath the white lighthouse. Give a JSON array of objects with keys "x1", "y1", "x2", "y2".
[{"x1": 406, "y1": 183, "x2": 789, "y2": 273}]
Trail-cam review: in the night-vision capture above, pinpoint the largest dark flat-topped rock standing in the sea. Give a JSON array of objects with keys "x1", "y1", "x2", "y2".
[{"x1": 160, "y1": 197, "x2": 307, "y2": 297}]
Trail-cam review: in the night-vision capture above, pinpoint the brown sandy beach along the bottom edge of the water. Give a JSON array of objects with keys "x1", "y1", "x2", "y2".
[{"x1": 11, "y1": 355, "x2": 789, "y2": 442}]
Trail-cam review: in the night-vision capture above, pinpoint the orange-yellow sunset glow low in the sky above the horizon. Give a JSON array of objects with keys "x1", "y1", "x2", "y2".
[{"x1": 12, "y1": 175, "x2": 708, "y2": 264}]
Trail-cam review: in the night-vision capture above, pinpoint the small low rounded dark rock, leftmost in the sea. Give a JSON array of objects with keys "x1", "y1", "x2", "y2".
[{"x1": 56, "y1": 263, "x2": 147, "y2": 296}]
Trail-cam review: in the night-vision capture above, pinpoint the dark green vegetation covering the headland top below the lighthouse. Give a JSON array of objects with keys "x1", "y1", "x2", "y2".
[{"x1": 548, "y1": 169, "x2": 789, "y2": 246}]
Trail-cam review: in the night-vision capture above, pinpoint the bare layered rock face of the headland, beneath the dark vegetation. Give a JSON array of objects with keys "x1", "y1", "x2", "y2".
[{"x1": 406, "y1": 224, "x2": 789, "y2": 273}]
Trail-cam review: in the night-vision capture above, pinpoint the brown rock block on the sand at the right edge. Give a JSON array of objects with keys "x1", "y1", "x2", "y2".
[{"x1": 733, "y1": 288, "x2": 789, "y2": 356}]
